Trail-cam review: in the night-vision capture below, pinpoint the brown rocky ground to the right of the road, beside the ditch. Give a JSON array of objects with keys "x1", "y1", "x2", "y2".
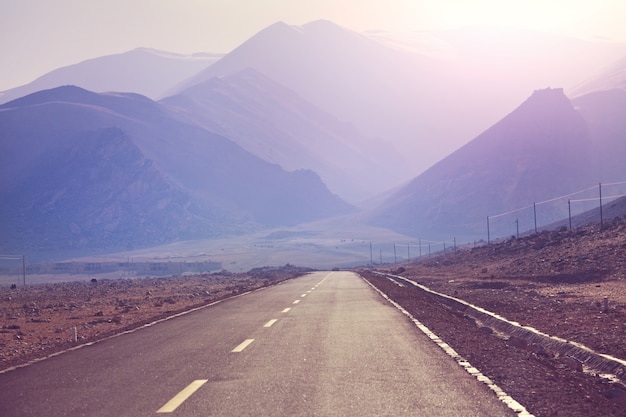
[{"x1": 360, "y1": 221, "x2": 626, "y2": 417}]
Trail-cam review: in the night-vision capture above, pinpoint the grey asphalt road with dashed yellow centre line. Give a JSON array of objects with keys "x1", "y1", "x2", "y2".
[{"x1": 0, "y1": 272, "x2": 514, "y2": 417}]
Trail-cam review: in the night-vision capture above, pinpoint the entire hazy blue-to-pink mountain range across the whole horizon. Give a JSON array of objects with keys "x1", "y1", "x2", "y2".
[{"x1": 0, "y1": 21, "x2": 626, "y2": 264}]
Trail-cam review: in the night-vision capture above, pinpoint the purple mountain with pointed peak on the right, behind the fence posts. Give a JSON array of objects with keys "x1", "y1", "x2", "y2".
[{"x1": 369, "y1": 89, "x2": 626, "y2": 239}]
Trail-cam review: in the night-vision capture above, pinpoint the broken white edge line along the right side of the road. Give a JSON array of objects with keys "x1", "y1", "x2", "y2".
[{"x1": 359, "y1": 275, "x2": 534, "y2": 417}]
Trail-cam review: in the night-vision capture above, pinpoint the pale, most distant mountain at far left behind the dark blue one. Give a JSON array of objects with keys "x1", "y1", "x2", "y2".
[{"x1": 0, "y1": 48, "x2": 222, "y2": 104}]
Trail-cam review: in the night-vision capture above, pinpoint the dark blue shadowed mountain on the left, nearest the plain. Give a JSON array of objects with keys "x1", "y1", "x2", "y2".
[{"x1": 0, "y1": 86, "x2": 352, "y2": 257}]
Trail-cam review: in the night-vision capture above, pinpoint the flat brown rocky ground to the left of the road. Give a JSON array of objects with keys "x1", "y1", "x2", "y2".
[{"x1": 0, "y1": 265, "x2": 308, "y2": 371}]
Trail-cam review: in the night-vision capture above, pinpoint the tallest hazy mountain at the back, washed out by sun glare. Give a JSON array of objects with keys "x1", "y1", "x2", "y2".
[{"x1": 172, "y1": 21, "x2": 626, "y2": 176}]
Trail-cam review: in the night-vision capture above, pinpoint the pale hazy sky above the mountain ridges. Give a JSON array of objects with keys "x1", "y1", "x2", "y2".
[{"x1": 0, "y1": 0, "x2": 626, "y2": 90}]
